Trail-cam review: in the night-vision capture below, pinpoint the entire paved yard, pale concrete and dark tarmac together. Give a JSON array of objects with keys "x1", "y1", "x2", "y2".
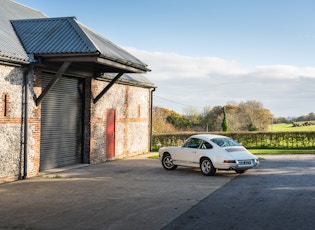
[{"x1": 0, "y1": 153, "x2": 315, "y2": 230}]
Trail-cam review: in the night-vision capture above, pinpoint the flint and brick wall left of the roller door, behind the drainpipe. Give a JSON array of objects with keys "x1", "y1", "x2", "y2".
[{"x1": 0, "y1": 65, "x2": 40, "y2": 183}]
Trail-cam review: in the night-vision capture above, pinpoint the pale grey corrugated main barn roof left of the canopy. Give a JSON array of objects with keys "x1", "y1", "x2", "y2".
[{"x1": 0, "y1": 0, "x2": 46, "y2": 62}]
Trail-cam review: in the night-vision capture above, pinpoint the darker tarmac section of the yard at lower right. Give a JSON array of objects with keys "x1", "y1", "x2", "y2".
[{"x1": 163, "y1": 155, "x2": 315, "y2": 230}]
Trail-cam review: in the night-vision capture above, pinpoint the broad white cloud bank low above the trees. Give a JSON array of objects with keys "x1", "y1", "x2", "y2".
[{"x1": 125, "y1": 47, "x2": 315, "y2": 117}]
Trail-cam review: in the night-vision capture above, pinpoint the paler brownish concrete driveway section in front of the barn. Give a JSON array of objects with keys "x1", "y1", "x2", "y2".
[{"x1": 0, "y1": 153, "x2": 238, "y2": 230}]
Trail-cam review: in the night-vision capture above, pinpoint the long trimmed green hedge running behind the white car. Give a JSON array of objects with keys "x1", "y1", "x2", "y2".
[{"x1": 152, "y1": 132, "x2": 315, "y2": 149}]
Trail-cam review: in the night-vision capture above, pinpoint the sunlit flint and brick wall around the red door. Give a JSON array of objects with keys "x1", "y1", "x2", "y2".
[{"x1": 91, "y1": 80, "x2": 151, "y2": 163}]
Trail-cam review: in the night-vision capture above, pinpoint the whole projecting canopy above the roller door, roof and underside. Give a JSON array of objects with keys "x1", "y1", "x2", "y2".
[{"x1": 11, "y1": 17, "x2": 150, "y2": 77}]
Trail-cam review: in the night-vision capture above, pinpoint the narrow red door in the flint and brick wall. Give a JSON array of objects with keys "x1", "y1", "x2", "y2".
[{"x1": 106, "y1": 109, "x2": 115, "y2": 159}]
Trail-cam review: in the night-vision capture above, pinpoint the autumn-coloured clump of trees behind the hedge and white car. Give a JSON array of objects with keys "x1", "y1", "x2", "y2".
[{"x1": 152, "y1": 101, "x2": 273, "y2": 133}]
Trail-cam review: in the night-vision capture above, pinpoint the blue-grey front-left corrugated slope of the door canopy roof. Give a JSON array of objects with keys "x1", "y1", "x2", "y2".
[{"x1": 11, "y1": 17, "x2": 97, "y2": 54}]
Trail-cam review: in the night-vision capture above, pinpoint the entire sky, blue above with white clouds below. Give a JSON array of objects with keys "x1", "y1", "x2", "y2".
[{"x1": 16, "y1": 0, "x2": 315, "y2": 117}]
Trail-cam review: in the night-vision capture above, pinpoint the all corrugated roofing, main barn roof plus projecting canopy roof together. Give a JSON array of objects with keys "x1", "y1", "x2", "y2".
[{"x1": 0, "y1": 0, "x2": 149, "y2": 72}]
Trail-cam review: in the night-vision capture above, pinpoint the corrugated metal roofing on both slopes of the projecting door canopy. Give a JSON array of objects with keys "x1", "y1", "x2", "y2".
[{"x1": 11, "y1": 17, "x2": 146, "y2": 68}]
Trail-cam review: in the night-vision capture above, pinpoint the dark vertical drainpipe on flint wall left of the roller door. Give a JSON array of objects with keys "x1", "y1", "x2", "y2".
[{"x1": 22, "y1": 69, "x2": 29, "y2": 179}]
